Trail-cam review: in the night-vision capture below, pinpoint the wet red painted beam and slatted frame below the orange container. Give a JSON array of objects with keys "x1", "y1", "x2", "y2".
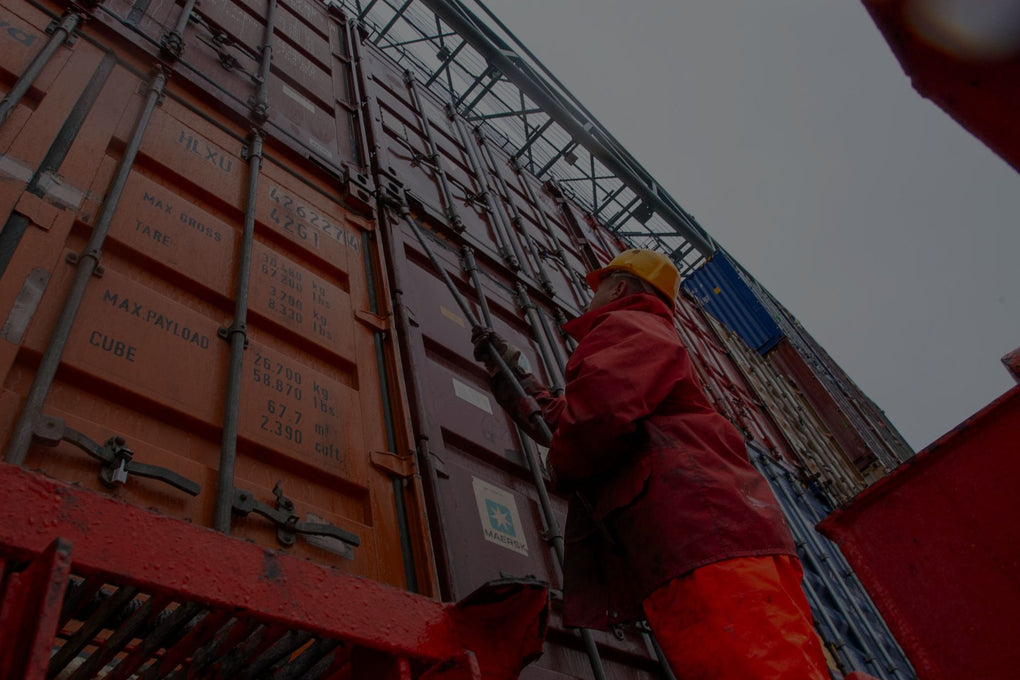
[{"x1": 0, "y1": 463, "x2": 548, "y2": 680}]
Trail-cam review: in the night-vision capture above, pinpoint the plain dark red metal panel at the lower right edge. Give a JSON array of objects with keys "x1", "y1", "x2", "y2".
[{"x1": 819, "y1": 387, "x2": 1020, "y2": 680}]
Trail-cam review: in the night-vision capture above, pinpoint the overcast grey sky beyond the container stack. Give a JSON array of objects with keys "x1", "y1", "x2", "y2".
[{"x1": 488, "y1": 0, "x2": 1020, "y2": 449}]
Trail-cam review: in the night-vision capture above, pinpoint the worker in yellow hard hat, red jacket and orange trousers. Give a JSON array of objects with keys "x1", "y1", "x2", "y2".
[{"x1": 473, "y1": 250, "x2": 829, "y2": 680}]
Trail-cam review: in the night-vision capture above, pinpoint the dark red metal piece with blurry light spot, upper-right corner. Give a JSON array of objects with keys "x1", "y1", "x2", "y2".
[{"x1": 863, "y1": 0, "x2": 1020, "y2": 170}]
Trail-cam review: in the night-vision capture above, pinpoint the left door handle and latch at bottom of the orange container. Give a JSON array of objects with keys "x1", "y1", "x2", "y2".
[{"x1": 32, "y1": 415, "x2": 202, "y2": 495}]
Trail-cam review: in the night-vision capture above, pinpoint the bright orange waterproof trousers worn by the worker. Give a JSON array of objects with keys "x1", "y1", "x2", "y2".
[{"x1": 644, "y1": 555, "x2": 829, "y2": 680}]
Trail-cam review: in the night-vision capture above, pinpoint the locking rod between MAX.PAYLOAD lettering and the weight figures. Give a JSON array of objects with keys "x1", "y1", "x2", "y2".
[{"x1": 213, "y1": 132, "x2": 262, "y2": 533}]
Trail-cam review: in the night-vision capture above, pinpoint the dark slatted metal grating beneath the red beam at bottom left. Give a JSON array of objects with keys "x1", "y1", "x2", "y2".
[{"x1": 30, "y1": 574, "x2": 350, "y2": 680}]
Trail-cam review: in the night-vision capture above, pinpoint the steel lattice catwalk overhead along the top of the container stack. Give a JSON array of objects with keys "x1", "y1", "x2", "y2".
[{"x1": 326, "y1": 0, "x2": 716, "y2": 273}]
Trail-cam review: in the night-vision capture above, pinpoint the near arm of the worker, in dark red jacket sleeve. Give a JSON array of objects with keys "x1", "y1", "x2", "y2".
[{"x1": 548, "y1": 312, "x2": 686, "y2": 482}]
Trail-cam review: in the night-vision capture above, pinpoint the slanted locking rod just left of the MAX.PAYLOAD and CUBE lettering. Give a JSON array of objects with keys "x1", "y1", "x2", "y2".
[{"x1": 5, "y1": 69, "x2": 166, "y2": 465}]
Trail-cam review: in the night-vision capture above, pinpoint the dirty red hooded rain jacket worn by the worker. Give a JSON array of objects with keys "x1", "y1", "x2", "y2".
[{"x1": 494, "y1": 294, "x2": 796, "y2": 628}]
